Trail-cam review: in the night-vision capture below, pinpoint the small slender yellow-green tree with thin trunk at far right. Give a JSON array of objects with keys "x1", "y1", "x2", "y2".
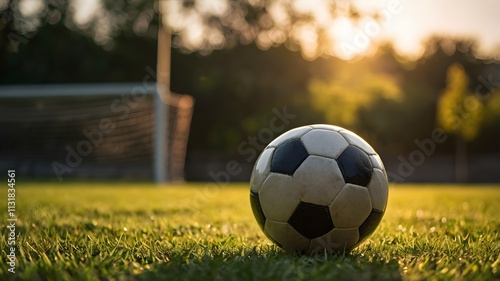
[{"x1": 437, "y1": 64, "x2": 484, "y2": 182}]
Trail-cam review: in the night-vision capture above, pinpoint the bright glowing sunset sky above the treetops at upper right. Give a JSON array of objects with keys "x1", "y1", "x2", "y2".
[{"x1": 295, "y1": 0, "x2": 500, "y2": 59}]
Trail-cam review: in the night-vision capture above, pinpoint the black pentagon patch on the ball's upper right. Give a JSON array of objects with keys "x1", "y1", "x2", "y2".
[{"x1": 337, "y1": 145, "x2": 373, "y2": 186}]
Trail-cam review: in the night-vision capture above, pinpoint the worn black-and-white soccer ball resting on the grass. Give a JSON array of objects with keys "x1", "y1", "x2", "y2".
[{"x1": 250, "y1": 125, "x2": 388, "y2": 254}]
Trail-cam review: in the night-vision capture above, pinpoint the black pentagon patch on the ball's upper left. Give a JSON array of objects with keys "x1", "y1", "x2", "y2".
[{"x1": 271, "y1": 139, "x2": 309, "y2": 176}]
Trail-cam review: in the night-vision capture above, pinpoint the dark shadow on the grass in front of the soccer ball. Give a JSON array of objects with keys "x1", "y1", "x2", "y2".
[{"x1": 134, "y1": 246, "x2": 402, "y2": 281}]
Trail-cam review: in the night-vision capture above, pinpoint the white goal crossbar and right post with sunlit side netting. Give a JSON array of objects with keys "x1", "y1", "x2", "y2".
[{"x1": 0, "y1": 82, "x2": 194, "y2": 183}]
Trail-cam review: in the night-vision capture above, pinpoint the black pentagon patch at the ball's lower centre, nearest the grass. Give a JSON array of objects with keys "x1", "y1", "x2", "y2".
[{"x1": 288, "y1": 202, "x2": 333, "y2": 239}]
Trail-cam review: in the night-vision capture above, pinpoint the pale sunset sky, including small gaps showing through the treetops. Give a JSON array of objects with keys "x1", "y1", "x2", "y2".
[{"x1": 13, "y1": 0, "x2": 500, "y2": 59}]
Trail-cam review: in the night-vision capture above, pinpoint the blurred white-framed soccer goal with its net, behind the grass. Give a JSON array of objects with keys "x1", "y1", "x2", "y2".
[{"x1": 0, "y1": 83, "x2": 194, "y2": 181}]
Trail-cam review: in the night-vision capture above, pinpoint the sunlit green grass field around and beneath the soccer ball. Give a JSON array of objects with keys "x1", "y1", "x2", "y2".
[{"x1": 0, "y1": 183, "x2": 500, "y2": 280}]
